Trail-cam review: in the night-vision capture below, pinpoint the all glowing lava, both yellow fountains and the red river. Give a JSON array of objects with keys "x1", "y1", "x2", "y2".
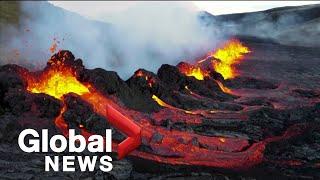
[{"x1": 20, "y1": 40, "x2": 312, "y2": 169}]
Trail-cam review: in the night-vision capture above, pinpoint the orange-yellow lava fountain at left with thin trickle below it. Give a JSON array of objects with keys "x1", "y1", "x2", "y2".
[{"x1": 25, "y1": 52, "x2": 90, "y2": 136}]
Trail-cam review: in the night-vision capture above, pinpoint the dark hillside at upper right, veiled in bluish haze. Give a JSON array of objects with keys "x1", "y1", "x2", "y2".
[{"x1": 202, "y1": 4, "x2": 320, "y2": 47}]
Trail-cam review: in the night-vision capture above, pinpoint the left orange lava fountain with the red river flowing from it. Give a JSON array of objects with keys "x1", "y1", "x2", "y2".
[{"x1": 18, "y1": 48, "x2": 312, "y2": 168}]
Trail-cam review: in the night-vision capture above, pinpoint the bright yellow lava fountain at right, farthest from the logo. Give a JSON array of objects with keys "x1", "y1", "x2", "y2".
[{"x1": 212, "y1": 39, "x2": 250, "y2": 79}]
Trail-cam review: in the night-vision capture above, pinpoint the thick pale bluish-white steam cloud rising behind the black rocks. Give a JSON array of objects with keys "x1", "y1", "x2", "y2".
[{"x1": 2, "y1": 2, "x2": 222, "y2": 78}]
